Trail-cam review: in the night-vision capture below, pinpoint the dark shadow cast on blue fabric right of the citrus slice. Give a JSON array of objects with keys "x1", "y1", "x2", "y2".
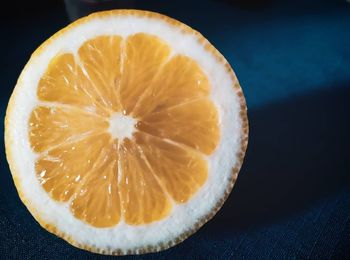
[{"x1": 209, "y1": 82, "x2": 350, "y2": 230}]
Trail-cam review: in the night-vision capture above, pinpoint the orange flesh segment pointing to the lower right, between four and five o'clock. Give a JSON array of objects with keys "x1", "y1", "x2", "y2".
[{"x1": 135, "y1": 133, "x2": 208, "y2": 203}]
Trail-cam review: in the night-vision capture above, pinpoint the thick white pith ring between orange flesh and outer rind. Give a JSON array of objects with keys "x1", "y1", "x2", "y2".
[{"x1": 6, "y1": 12, "x2": 242, "y2": 252}]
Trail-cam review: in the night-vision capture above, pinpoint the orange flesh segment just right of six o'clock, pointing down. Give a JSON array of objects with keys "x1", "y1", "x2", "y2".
[{"x1": 119, "y1": 139, "x2": 171, "y2": 225}]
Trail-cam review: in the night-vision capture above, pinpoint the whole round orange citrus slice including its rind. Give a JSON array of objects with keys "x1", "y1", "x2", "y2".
[{"x1": 5, "y1": 10, "x2": 248, "y2": 254}]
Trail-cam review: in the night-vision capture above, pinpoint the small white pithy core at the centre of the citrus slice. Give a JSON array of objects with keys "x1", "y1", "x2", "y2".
[{"x1": 108, "y1": 113, "x2": 137, "y2": 140}]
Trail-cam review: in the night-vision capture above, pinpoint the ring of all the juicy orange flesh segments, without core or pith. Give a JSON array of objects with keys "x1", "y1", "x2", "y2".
[{"x1": 29, "y1": 33, "x2": 220, "y2": 227}]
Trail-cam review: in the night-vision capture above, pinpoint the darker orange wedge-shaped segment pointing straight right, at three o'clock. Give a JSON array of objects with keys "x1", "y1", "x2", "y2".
[{"x1": 137, "y1": 98, "x2": 220, "y2": 155}]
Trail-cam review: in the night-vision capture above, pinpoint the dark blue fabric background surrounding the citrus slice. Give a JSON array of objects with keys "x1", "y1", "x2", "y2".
[{"x1": 0, "y1": 0, "x2": 350, "y2": 259}]
